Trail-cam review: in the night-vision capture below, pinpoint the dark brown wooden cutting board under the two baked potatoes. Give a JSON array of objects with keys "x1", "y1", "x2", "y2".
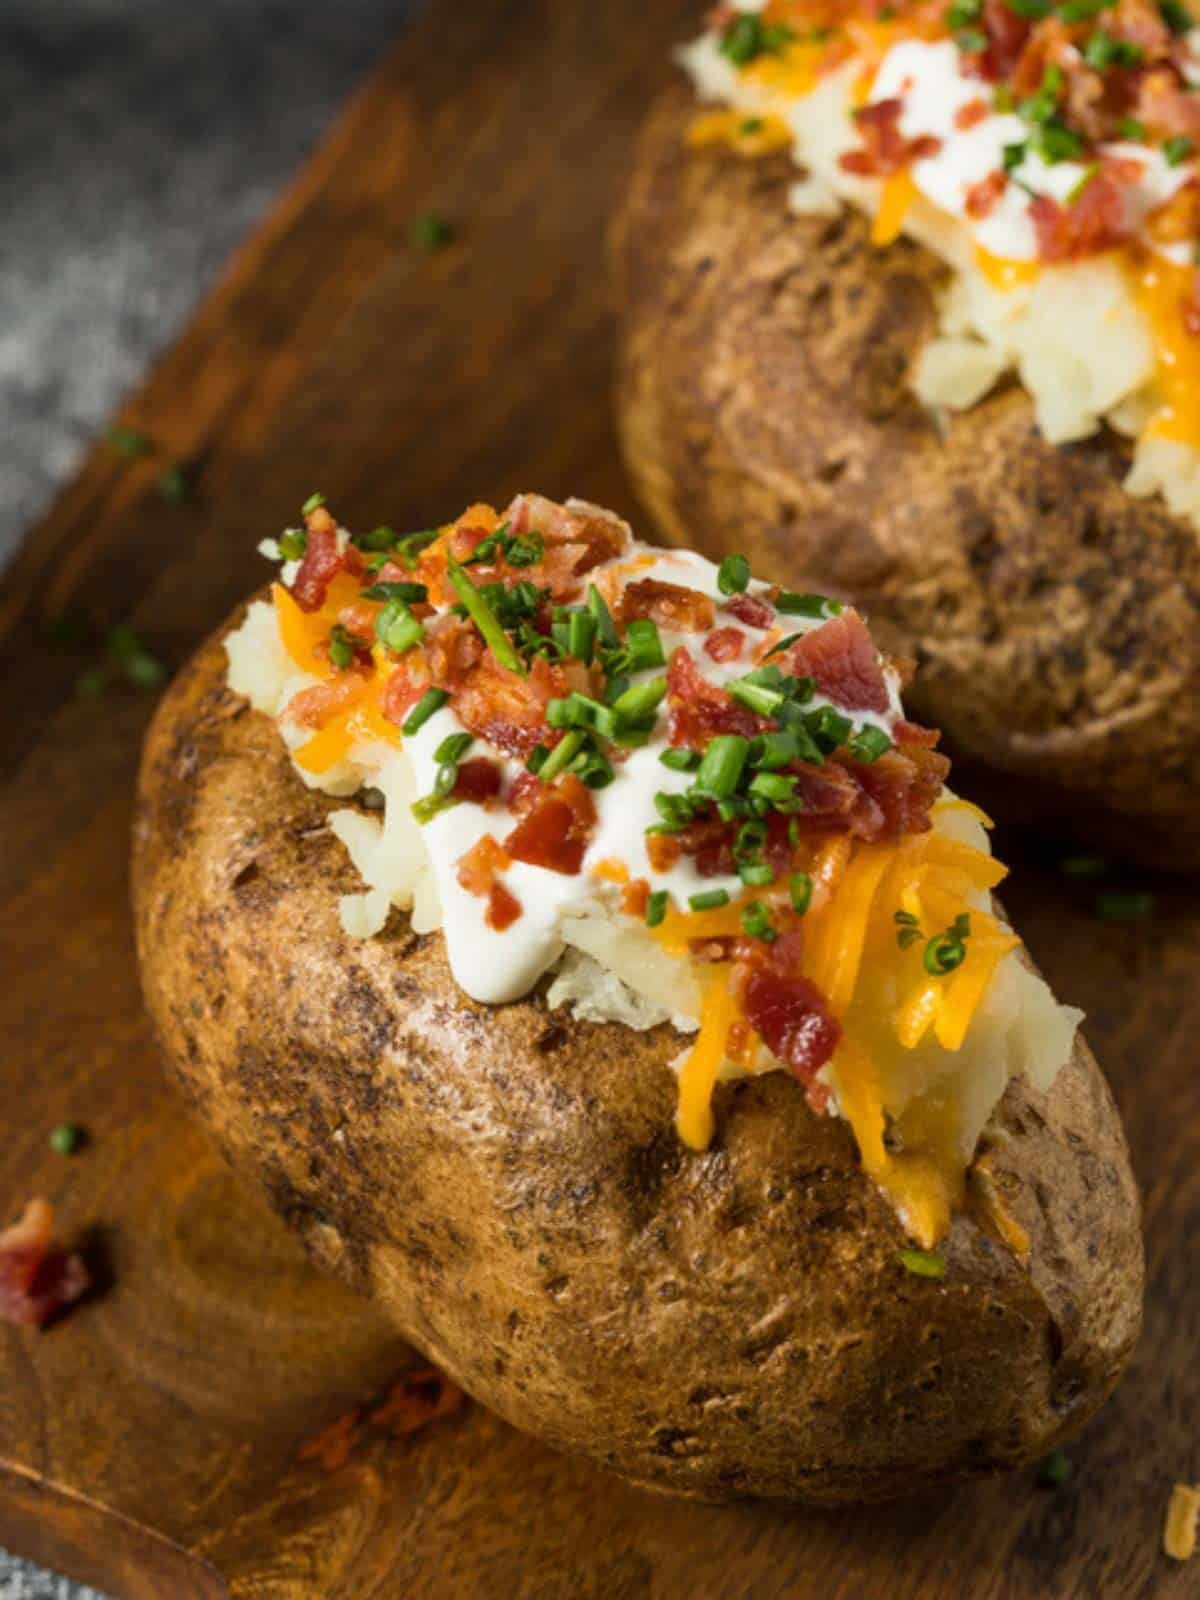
[{"x1": 0, "y1": 0, "x2": 1200, "y2": 1600}]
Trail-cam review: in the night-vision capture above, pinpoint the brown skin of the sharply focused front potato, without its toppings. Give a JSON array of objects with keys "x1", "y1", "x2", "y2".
[{"x1": 134, "y1": 611, "x2": 1142, "y2": 1502}]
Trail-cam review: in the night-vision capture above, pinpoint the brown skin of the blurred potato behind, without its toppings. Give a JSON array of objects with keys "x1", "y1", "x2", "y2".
[{"x1": 611, "y1": 85, "x2": 1200, "y2": 870}]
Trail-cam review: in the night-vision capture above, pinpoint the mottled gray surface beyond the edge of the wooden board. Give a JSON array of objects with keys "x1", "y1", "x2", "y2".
[{"x1": 0, "y1": 0, "x2": 414, "y2": 1600}]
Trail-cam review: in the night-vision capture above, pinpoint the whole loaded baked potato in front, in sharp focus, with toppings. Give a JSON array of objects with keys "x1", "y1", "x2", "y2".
[{"x1": 134, "y1": 496, "x2": 1142, "y2": 1502}]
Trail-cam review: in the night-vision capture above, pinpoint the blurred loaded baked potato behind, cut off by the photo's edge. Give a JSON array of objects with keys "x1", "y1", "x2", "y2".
[{"x1": 613, "y1": 0, "x2": 1200, "y2": 867}]
